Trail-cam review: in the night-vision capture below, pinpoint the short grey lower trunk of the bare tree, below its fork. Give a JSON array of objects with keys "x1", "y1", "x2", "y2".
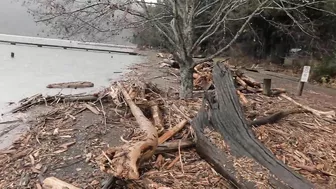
[{"x1": 180, "y1": 63, "x2": 194, "y2": 99}]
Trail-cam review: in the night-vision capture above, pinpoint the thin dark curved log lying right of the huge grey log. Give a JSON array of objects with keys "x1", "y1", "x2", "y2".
[{"x1": 249, "y1": 109, "x2": 308, "y2": 127}]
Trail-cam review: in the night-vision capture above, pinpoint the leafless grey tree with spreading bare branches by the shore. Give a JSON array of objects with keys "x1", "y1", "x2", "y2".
[{"x1": 27, "y1": 0, "x2": 336, "y2": 98}]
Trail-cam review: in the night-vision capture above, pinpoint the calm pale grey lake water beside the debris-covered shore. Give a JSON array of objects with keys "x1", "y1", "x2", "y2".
[{"x1": 0, "y1": 44, "x2": 141, "y2": 112}]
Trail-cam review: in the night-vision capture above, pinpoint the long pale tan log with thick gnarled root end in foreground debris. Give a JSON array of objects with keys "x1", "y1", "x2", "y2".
[{"x1": 98, "y1": 83, "x2": 158, "y2": 180}]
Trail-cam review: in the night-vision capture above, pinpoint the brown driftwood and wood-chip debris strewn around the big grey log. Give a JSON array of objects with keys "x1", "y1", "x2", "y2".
[{"x1": 0, "y1": 55, "x2": 336, "y2": 189}]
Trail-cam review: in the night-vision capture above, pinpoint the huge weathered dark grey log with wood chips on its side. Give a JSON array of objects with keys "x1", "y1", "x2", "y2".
[{"x1": 192, "y1": 64, "x2": 313, "y2": 189}]
